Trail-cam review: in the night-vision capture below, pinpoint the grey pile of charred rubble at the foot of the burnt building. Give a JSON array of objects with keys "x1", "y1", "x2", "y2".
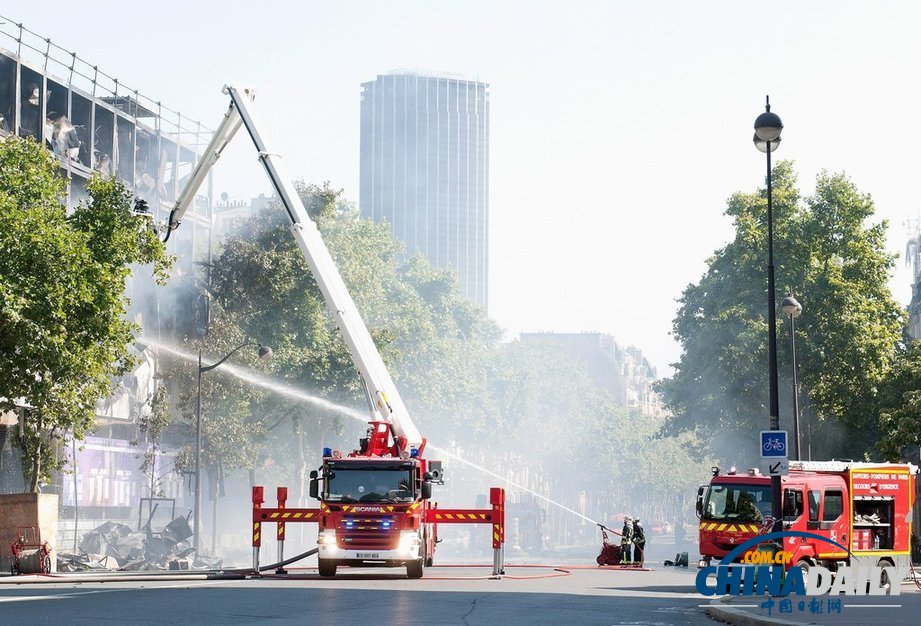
[{"x1": 57, "y1": 517, "x2": 222, "y2": 572}]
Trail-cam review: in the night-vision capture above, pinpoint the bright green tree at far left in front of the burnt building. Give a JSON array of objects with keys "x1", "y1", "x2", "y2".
[{"x1": 0, "y1": 137, "x2": 170, "y2": 491}]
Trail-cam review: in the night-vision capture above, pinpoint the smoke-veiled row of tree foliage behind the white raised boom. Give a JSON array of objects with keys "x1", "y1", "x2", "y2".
[{"x1": 164, "y1": 176, "x2": 709, "y2": 512}]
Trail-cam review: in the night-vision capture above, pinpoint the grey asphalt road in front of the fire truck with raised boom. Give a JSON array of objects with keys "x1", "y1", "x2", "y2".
[{"x1": 0, "y1": 567, "x2": 715, "y2": 626}]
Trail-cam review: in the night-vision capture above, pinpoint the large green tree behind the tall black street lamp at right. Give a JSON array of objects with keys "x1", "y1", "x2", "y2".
[{"x1": 660, "y1": 162, "x2": 903, "y2": 457}]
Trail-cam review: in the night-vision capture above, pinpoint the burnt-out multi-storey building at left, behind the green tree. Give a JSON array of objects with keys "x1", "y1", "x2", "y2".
[{"x1": 0, "y1": 16, "x2": 212, "y2": 545}]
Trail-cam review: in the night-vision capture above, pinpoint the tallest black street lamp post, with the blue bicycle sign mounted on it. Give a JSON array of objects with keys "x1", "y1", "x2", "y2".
[{"x1": 754, "y1": 96, "x2": 783, "y2": 527}]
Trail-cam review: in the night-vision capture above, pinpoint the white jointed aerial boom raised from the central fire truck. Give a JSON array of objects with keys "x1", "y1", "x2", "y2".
[{"x1": 164, "y1": 85, "x2": 424, "y2": 449}]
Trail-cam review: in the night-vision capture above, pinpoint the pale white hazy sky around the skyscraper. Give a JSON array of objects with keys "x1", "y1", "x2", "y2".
[{"x1": 0, "y1": 0, "x2": 921, "y2": 373}]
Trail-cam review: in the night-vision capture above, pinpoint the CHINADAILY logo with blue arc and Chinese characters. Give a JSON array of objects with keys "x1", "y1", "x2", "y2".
[{"x1": 696, "y1": 531, "x2": 908, "y2": 614}]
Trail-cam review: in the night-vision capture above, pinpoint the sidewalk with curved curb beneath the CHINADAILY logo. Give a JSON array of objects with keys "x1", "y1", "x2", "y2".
[{"x1": 705, "y1": 583, "x2": 921, "y2": 626}]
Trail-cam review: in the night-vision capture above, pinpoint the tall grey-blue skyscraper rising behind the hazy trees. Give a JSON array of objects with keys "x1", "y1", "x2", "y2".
[{"x1": 359, "y1": 71, "x2": 489, "y2": 308}]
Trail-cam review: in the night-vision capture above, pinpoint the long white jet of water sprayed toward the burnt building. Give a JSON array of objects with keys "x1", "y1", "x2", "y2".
[{"x1": 140, "y1": 337, "x2": 601, "y2": 525}]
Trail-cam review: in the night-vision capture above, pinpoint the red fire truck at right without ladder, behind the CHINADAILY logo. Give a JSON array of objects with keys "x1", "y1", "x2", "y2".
[{"x1": 697, "y1": 461, "x2": 918, "y2": 569}]
